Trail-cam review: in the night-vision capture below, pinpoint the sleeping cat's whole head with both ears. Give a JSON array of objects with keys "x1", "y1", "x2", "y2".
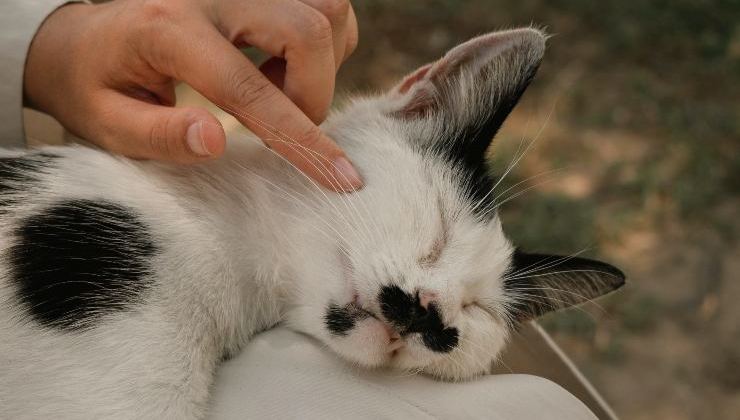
[{"x1": 288, "y1": 28, "x2": 624, "y2": 379}]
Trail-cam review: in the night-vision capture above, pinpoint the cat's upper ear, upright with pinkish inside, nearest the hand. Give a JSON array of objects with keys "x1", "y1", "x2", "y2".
[{"x1": 388, "y1": 28, "x2": 546, "y2": 159}]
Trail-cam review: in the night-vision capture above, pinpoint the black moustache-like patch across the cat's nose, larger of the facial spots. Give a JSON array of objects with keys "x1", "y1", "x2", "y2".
[{"x1": 378, "y1": 286, "x2": 458, "y2": 353}]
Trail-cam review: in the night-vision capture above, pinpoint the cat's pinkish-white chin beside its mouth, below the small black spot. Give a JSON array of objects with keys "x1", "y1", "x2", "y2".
[{"x1": 330, "y1": 318, "x2": 394, "y2": 367}]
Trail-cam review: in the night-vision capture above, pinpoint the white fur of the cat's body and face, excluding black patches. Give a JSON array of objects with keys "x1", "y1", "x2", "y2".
[{"x1": 0, "y1": 29, "x2": 544, "y2": 419}]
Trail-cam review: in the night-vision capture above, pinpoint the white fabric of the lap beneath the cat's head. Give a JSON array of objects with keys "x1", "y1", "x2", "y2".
[{"x1": 211, "y1": 328, "x2": 596, "y2": 420}]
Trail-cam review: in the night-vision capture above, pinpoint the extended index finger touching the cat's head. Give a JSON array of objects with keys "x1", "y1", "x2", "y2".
[{"x1": 141, "y1": 24, "x2": 362, "y2": 191}]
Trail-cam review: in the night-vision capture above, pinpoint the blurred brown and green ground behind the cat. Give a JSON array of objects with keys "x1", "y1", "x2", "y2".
[{"x1": 337, "y1": 0, "x2": 740, "y2": 419}]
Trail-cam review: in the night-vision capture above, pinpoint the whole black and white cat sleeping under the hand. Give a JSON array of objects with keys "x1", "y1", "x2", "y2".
[{"x1": 0, "y1": 28, "x2": 624, "y2": 419}]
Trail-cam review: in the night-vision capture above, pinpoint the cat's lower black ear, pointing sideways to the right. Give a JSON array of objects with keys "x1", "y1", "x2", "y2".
[{"x1": 504, "y1": 249, "x2": 624, "y2": 321}]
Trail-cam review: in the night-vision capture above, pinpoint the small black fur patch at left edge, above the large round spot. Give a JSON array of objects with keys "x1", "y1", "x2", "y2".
[{"x1": 0, "y1": 153, "x2": 58, "y2": 214}]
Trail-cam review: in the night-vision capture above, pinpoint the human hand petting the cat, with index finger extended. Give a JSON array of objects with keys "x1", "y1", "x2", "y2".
[{"x1": 24, "y1": 0, "x2": 362, "y2": 191}]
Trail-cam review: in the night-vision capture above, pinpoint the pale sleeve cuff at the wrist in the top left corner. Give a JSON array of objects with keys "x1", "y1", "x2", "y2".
[{"x1": 0, "y1": 0, "x2": 82, "y2": 147}]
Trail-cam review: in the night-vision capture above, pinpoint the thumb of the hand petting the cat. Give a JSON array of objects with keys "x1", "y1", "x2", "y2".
[{"x1": 92, "y1": 94, "x2": 226, "y2": 163}]
